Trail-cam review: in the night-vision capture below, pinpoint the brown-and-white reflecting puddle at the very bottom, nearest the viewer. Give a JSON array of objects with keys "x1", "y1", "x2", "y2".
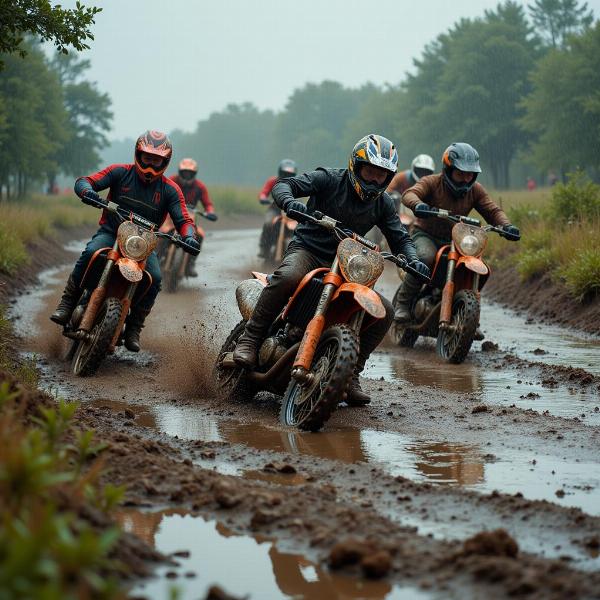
[{"x1": 123, "y1": 511, "x2": 431, "y2": 600}]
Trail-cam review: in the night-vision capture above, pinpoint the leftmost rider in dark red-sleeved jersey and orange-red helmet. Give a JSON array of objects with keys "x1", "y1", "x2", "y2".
[{"x1": 50, "y1": 131, "x2": 200, "y2": 352}]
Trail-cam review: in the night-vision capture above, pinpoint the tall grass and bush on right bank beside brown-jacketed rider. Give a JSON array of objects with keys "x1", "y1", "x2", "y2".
[{"x1": 488, "y1": 173, "x2": 600, "y2": 302}]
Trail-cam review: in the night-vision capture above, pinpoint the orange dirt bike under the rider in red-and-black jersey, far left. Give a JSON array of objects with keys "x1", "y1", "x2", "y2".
[{"x1": 63, "y1": 201, "x2": 196, "y2": 376}]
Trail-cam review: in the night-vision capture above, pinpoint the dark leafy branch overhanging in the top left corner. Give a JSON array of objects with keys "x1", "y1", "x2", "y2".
[{"x1": 0, "y1": 0, "x2": 102, "y2": 70}]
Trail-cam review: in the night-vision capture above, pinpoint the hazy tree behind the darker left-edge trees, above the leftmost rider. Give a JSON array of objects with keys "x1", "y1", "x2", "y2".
[{"x1": 48, "y1": 54, "x2": 112, "y2": 186}]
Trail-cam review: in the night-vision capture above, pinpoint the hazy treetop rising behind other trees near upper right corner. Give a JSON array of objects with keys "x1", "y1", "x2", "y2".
[{"x1": 529, "y1": 0, "x2": 594, "y2": 48}]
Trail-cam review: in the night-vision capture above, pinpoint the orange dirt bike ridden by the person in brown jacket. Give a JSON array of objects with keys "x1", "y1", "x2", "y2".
[{"x1": 390, "y1": 209, "x2": 520, "y2": 363}]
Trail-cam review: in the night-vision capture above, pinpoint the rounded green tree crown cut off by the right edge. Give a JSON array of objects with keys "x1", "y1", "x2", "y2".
[{"x1": 522, "y1": 22, "x2": 600, "y2": 174}]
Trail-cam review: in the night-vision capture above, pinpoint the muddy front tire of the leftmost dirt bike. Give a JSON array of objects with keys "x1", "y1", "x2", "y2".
[{"x1": 71, "y1": 298, "x2": 123, "y2": 377}]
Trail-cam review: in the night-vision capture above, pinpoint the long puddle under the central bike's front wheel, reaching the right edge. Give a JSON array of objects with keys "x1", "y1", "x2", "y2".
[{"x1": 94, "y1": 400, "x2": 600, "y2": 515}]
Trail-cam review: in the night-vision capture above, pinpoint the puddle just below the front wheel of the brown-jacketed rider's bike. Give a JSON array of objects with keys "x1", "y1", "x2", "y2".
[{"x1": 364, "y1": 343, "x2": 600, "y2": 425}]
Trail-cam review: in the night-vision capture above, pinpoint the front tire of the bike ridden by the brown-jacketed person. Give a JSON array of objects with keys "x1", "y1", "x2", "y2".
[{"x1": 437, "y1": 290, "x2": 480, "y2": 364}]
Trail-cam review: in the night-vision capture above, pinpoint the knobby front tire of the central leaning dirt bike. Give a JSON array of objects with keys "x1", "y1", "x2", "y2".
[{"x1": 279, "y1": 325, "x2": 358, "y2": 431}]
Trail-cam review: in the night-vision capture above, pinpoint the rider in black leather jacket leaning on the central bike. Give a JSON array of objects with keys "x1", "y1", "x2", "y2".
[{"x1": 233, "y1": 134, "x2": 429, "y2": 406}]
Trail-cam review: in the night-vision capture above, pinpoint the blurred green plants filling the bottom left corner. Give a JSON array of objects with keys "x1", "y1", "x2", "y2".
[{"x1": 0, "y1": 381, "x2": 122, "y2": 600}]
